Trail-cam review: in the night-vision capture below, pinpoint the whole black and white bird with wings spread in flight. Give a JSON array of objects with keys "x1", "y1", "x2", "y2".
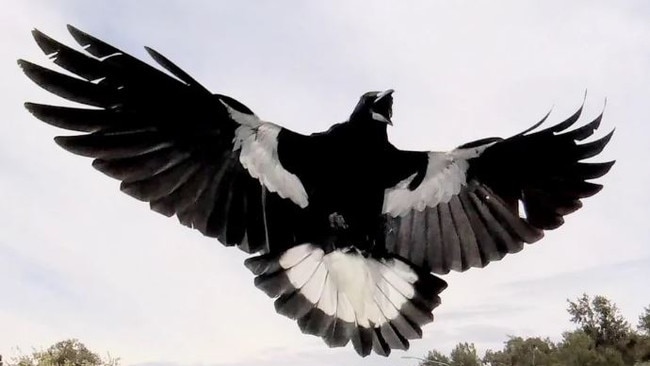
[{"x1": 18, "y1": 26, "x2": 613, "y2": 356}]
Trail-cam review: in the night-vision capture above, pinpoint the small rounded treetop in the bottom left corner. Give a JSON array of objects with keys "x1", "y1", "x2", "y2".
[{"x1": 8, "y1": 339, "x2": 119, "y2": 366}]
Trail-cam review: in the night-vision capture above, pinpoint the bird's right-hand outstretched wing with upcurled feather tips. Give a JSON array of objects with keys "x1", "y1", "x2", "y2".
[{"x1": 383, "y1": 108, "x2": 614, "y2": 273}]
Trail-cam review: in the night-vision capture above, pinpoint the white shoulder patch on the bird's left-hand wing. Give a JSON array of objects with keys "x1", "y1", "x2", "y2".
[{"x1": 222, "y1": 101, "x2": 309, "y2": 208}]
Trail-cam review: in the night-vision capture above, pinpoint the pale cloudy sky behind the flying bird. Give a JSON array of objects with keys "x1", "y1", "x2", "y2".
[{"x1": 0, "y1": 0, "x2": 650, "y2": 366}]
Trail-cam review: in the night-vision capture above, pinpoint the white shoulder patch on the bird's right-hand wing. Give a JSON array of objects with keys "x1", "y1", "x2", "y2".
[{"x1": 383, "y1": 144, "x2": 492, "y2": 217}]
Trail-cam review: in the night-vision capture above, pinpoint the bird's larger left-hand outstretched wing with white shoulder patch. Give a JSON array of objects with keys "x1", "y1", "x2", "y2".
[{"x1": 18, "y1": 26, "x2": 309, "y2": 252}]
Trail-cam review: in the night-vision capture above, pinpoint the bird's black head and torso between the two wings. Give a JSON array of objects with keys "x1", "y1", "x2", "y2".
[{"x1": 278, "y1": 92, "x2": 427, "y2": 254}]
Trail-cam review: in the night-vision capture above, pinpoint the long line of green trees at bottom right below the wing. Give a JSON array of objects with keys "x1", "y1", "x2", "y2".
[{"x1": 420, "y1": 294, "x2": 650, "y2": 366}]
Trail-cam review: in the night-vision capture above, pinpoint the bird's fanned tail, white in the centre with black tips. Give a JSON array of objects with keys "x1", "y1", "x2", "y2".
[{"x1": 246, "y1": 244, "x2": 447, "y2": 356}]
